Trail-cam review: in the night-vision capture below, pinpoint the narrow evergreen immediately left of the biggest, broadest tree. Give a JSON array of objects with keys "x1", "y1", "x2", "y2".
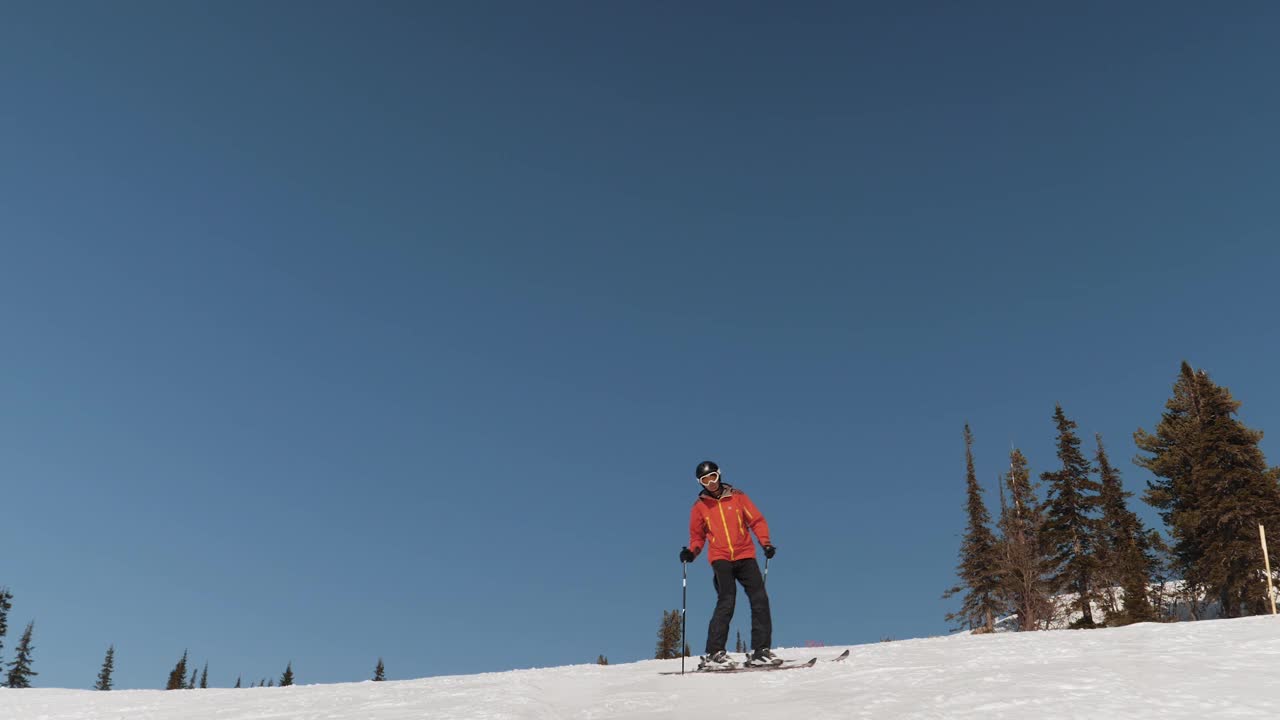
[{"x1": 1094, "y1": 434, "x2": 1156, "y2": 625}]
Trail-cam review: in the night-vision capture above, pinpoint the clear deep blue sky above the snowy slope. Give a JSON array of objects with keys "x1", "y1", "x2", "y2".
[{"x1": 0, "y1": 3, "x2": 1280, "y2": 687}]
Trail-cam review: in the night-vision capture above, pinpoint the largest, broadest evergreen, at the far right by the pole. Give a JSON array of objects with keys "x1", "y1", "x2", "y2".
[{"x1": 1134, "y1": 363, "x2": 1280, "y2": 618}]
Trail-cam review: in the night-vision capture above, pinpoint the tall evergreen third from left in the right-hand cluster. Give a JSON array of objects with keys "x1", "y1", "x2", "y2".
[{"x1": 1041, "y1": 405, "x2": 1101, "y2": 628}]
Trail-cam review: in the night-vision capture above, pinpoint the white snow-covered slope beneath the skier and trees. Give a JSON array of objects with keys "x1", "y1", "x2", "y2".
[{"x1": 0, "y1": 616, "x2": 1280, "y2": 720}]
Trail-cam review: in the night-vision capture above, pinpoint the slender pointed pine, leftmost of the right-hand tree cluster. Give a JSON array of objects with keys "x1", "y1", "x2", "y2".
[{"x1": 942, "y1": 424, "x2": 1001, "y2": 633}]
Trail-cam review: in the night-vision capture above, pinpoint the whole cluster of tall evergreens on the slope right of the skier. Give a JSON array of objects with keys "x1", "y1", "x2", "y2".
[{"x1": 943, "y1": 363, "x2": 1280, "y2": 632}]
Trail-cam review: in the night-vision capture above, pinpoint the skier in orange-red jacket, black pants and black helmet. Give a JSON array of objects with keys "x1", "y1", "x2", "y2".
[{"x1": 680, "y1": 460, "x2": 782, "y2": 670}]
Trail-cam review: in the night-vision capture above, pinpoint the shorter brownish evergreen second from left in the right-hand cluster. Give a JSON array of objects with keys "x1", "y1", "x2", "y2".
[{"x1": 998, "y1": 448, "x2": 1053, "y2": 630}]
